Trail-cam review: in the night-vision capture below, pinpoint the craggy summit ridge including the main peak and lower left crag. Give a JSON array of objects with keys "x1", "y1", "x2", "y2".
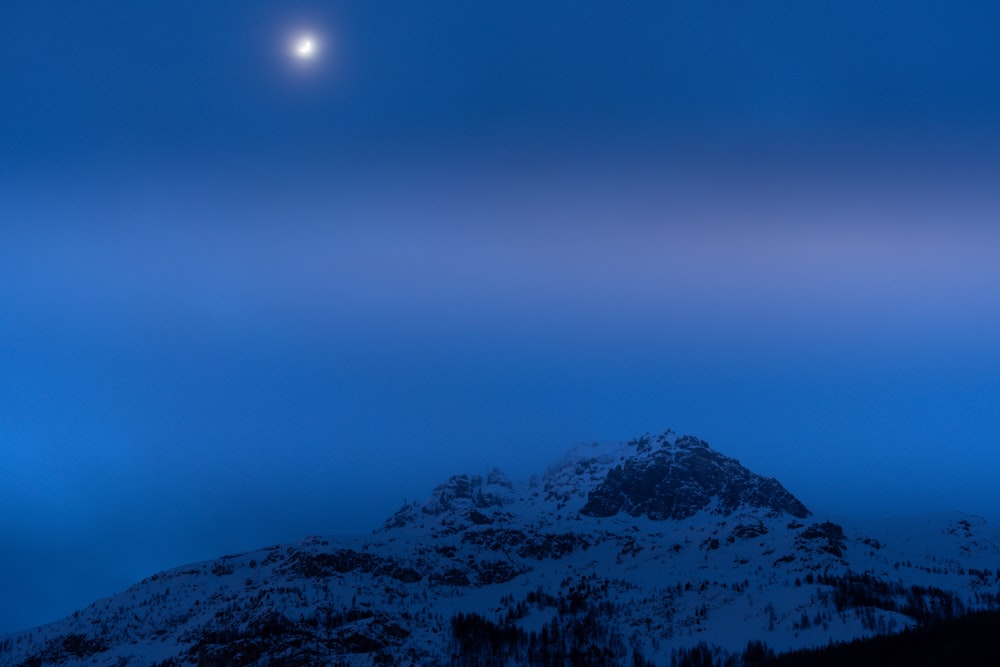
[{"x1": 384, "y1": 429, "x2": 811, "y2": 530}]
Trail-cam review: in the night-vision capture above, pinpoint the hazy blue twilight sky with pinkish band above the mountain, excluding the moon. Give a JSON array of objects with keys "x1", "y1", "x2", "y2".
[{"x1": 0, "y1": 0, "x2": 1000, "y2": 633}]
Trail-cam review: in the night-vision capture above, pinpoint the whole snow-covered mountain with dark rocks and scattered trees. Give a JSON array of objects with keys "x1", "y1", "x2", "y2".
[{"x1": 0, "y1": 431, "x2": 1000, "y2": 666}]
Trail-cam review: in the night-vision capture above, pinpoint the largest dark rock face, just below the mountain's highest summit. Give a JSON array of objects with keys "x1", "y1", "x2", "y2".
[{"x1": 580, "y1": 436, "x2": 810, "y2": 521}]
